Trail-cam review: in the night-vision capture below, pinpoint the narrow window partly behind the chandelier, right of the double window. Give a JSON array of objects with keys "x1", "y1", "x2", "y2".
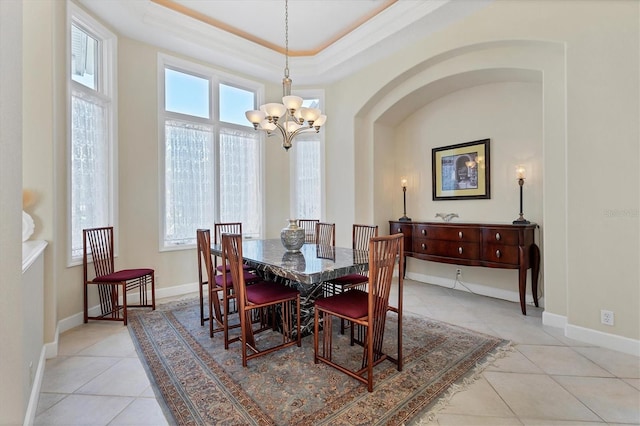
[{"x1": 290, "y1": 97, "x2": 324, "y2": 219}]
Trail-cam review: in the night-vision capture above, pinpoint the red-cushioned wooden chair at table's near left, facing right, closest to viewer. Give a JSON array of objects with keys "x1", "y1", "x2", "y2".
[{"x1": 222, "y1": 234, "x2": 302, "y2": 367}]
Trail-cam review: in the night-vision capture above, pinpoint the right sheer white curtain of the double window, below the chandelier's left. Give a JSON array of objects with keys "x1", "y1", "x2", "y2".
[{"x1": 220, "y1": 128, "x2": 262, "y2": 238}]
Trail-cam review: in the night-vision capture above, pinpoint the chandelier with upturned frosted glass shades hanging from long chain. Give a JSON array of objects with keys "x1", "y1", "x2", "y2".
[{"x1": 245, "y1": 0, "x2": 327, "y2": 151}]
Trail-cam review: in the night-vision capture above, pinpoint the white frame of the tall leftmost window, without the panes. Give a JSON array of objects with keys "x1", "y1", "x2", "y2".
[{"x1": 65, "y1": 1, "x2": 118, "y2": 267}]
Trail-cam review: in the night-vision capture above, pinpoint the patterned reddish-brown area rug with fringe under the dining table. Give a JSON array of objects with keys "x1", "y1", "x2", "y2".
[{"x1": 129, "y1": 298, "x2": 509, "y2": 425}]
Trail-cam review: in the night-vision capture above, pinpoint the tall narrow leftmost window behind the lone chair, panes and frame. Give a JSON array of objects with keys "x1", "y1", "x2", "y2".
[{"x1": 68, "y1": 3, "x2": 117, "y2": 264}]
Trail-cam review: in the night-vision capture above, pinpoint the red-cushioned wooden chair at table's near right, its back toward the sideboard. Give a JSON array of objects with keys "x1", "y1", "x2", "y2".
[{"x1": 313, "y1": 234, "x2": 404, "y2": 392}]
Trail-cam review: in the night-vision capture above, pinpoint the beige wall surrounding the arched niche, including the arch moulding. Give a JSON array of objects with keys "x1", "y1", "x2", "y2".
[{"x1": 326, "y1": 1, "x2": 640, "y2": 339}]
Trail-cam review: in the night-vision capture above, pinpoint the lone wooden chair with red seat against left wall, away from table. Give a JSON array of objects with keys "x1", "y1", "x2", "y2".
[{"x1": 82, "y1": 226, "x2": 156, "y2": 325}]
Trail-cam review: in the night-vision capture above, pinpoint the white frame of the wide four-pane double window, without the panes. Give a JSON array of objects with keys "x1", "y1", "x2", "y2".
[{"x1": 157, "y1": 53, "x2": 266, "y2": 252}]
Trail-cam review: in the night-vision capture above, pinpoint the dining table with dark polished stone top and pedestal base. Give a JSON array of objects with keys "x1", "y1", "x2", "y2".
[{"x1": 211, "y1": 239, "x2": 369, "y2": 336}]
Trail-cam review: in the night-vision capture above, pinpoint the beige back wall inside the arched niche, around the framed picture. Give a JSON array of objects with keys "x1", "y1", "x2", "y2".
[{"x1": 392, "y1": 82, "x2": 544, "y2": 301}]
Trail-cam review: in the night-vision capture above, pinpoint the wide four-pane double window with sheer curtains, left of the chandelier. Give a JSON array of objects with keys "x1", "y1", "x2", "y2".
[{"x1": 159, "y1": 55, "x2": 263, "y2": 250}]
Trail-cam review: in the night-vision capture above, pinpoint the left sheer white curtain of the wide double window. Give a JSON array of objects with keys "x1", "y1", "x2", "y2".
[{"x1": 165, "y1": 120, "x2": 215, "y2": 245}]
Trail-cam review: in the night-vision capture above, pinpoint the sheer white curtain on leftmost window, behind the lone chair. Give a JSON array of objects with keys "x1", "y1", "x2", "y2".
[{"x1": 70, "y1": 91, "x2": 111, "y2": 257}]
